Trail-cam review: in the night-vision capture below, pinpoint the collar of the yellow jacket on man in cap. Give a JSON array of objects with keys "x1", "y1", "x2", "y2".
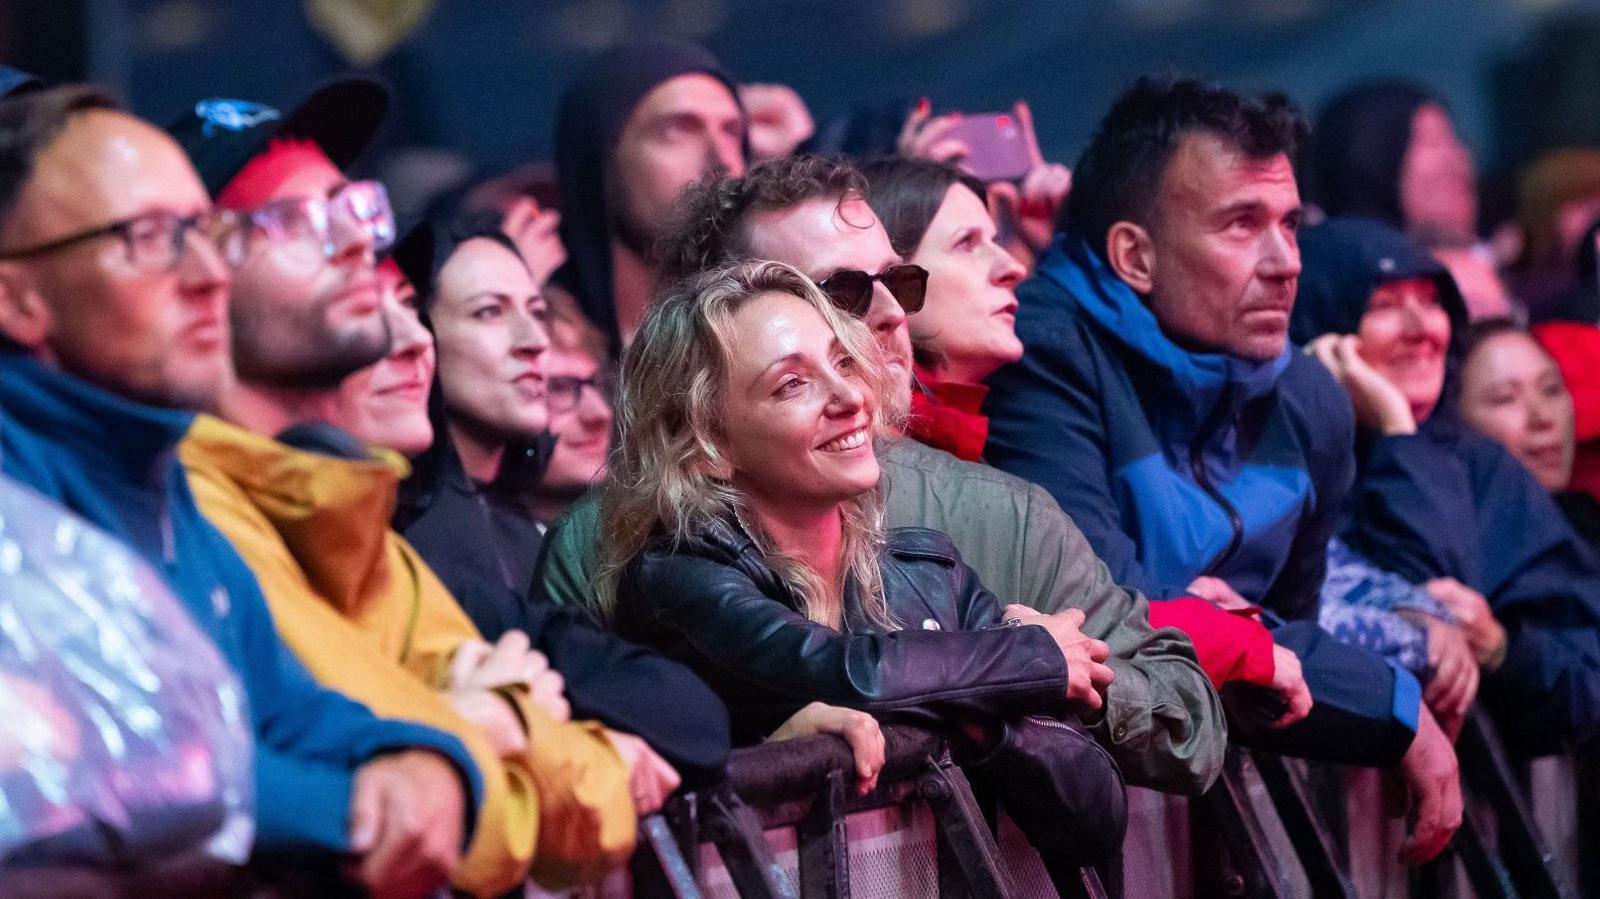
[{"x1": 182, "y1": 416, "x2": 406, "y2": 614}]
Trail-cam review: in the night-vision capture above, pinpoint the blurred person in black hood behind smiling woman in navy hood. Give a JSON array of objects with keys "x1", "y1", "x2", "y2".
[{"x1": 1306, "y1": 80, "x2": 1478, "y2": 238}]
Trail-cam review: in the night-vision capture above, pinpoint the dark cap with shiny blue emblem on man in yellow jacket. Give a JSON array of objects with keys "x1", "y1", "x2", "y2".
[{"x1": 166, "y1": 75, "x2": 390, "y2": 197}]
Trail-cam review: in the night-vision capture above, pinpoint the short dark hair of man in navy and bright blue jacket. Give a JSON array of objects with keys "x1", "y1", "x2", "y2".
[{"x1": 1056, "y1": 78, "x2": 1307, "y2": 256}]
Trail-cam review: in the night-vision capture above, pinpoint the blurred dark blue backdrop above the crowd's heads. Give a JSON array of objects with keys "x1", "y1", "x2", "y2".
[{"x1": 9, "y1": 0, "x2": 1600, "y2": 220}]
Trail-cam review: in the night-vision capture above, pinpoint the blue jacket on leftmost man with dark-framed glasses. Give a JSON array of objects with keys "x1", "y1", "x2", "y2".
[{"x1": 0, "y1": 352, "x2": 483, "y2": 853}]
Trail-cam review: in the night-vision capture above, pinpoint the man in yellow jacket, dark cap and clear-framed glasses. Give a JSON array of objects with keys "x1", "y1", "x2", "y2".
[{"x1": 171, "y1": 78, "x2": 634, "y2": 894}]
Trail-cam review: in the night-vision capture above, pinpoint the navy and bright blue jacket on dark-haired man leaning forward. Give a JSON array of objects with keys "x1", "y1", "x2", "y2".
[{"x1": 984, "y1": 237, "x2": 1421, "y2": 765}]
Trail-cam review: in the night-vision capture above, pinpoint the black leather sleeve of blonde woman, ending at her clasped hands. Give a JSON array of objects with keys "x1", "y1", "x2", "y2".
[{"x1": 618, "y1": 550, "x2": 1067, "y2": 737}]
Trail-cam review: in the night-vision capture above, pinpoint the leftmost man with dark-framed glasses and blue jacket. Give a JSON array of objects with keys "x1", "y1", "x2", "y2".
[{"x1": 0, "y1": 86, "x2": 482, "y2": 896}]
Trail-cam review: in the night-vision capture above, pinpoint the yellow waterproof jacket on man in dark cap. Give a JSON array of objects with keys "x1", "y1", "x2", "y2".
[{"x1": 179, "y1": 416, "x2": 634, "y2": 896}]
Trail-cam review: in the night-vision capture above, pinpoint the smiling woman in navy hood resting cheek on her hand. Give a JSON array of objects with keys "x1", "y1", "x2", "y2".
[{"x1": 1291, "y1": 212, "x2": 1600, "y2": 755}]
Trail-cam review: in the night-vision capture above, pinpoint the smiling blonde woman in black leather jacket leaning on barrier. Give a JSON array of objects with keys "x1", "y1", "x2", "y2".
[{"x1": 597, "y1": 262, "x2": 1125, "y2": 881}]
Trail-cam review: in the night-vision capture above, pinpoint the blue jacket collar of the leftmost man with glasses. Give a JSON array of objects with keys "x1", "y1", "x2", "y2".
[{"x1": 0, "y1": 352, "x2": 195, "y2": 483}]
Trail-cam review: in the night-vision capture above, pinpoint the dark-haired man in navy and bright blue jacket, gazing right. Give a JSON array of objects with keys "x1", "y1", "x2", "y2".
[{"x1": 984, "y1": 80, "x2": 1461, "y2": 859}]
